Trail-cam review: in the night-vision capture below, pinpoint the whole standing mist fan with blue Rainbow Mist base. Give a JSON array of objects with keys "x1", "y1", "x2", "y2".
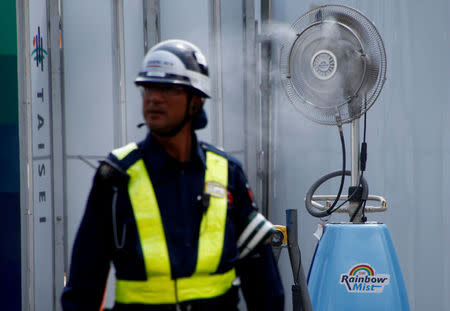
[{"x1": 280, "y1": 5, "x2": 409, "y2": 311}]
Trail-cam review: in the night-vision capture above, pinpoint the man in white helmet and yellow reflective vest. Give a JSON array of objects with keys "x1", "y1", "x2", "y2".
[{"x1": 62, "y1": 40, "x2": 284, "y2": 311}]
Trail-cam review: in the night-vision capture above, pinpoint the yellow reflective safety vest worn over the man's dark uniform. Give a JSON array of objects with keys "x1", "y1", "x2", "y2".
[{"x1": 112, "y1": 143, "x2": 236, "y2": 304}]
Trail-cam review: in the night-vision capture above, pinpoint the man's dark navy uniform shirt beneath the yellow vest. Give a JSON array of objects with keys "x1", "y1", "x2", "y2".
[{"x1": 62, "y1": 134, "x2": 284, "y2": 311}]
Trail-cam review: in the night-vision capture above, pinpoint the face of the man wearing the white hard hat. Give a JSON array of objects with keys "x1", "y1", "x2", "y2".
[{"x1": 142, "y1": 83, "x2": 188, "y2": 136}]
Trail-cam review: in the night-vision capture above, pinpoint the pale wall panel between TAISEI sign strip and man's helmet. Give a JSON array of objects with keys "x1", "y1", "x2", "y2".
[{"x1": 63, "y1": 0, "x2": 115, "y2": 156}]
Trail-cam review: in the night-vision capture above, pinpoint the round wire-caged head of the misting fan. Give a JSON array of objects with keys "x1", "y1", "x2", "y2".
[{"x1": 280, "y1": 5, "x2": 386, "y2": 125}]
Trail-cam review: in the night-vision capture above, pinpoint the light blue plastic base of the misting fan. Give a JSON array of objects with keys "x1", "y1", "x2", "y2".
[{"x1": 308, "y1": 223, "x2": 409, "y2": 311}]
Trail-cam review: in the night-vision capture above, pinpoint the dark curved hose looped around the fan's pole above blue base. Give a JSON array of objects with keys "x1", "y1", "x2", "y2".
[{"x1": 305, "y1": 171, "x2": 369, "y2": 218}]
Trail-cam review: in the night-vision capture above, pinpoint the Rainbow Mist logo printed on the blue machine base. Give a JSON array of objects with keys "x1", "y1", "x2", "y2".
[{"x1": 339, "y1": 263, "x2": 390, "y2": 293}]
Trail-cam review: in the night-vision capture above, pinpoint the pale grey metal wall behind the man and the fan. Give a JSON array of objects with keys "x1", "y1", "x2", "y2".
[{"x1": 19, "y1": 0, "x2": 450, "y2": 310}]
